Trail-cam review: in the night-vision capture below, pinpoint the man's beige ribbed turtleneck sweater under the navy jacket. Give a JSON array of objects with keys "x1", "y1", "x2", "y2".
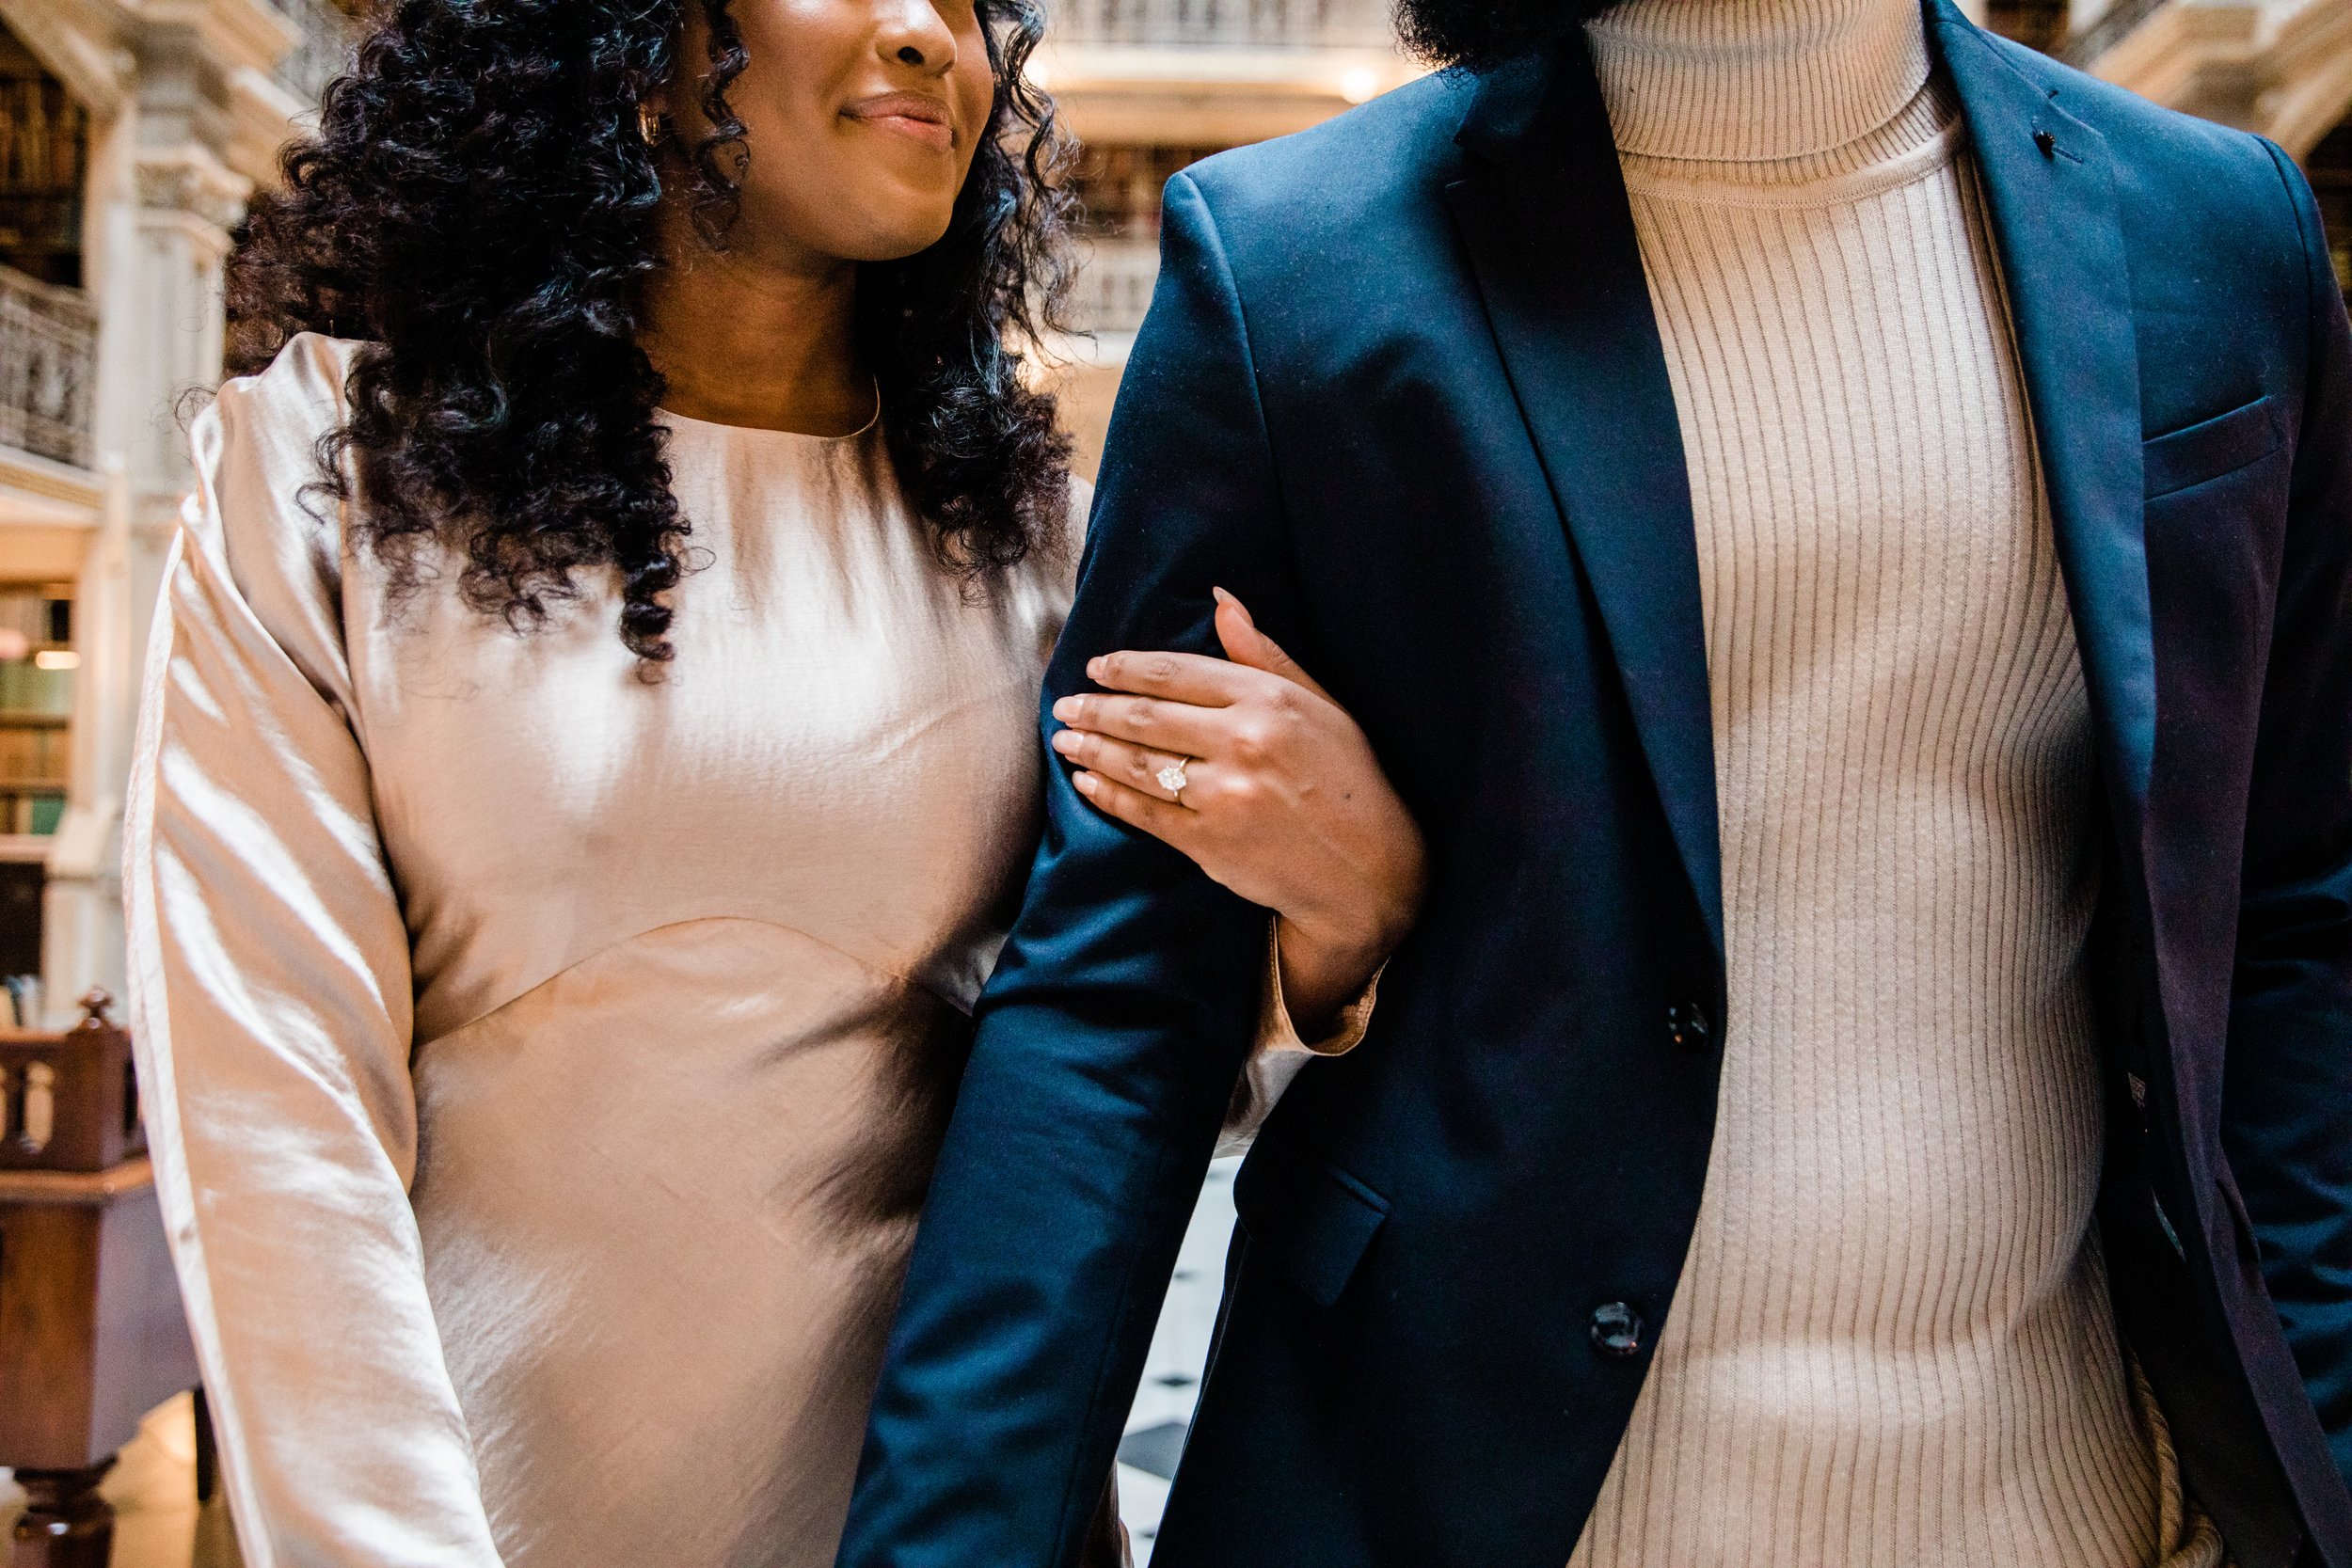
[{"x1": 1574, "y1": 0, "x2": 2220, "y2": 1568}]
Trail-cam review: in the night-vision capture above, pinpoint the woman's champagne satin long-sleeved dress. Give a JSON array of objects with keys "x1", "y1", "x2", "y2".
[{"x1": 125, "y1": 336, "x2": 1157, "y2": 1568}]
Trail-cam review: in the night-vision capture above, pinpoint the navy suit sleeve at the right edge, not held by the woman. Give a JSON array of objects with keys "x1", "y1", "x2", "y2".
[{"x1": 2223, "y1": 148, "x2": 2352, "y2": 1477}]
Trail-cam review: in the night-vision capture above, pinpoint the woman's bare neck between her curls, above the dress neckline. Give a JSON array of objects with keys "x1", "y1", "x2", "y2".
[{"x1": 638, "y1": 208, "x2": 875, "y2": 435}]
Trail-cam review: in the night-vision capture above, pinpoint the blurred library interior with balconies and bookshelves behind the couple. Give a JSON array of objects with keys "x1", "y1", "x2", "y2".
[{"x1": 0, "y1": 0, "x2": 2352, "y2": 1563}]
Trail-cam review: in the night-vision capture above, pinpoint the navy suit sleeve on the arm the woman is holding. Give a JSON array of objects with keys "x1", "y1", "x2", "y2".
[{"x1": 840, "y1": 174, "x2": 1296, "y2": 1568}]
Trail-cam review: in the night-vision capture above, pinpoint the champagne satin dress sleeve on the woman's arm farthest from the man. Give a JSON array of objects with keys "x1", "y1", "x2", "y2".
[{"x1": 125, "y1": 341, "x2": 499, "y2": 1568}]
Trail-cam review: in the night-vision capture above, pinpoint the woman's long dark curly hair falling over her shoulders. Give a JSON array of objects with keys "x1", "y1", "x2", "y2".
[{"x1": 229, "y1": 0, "x2": 1068, "y2": 673}]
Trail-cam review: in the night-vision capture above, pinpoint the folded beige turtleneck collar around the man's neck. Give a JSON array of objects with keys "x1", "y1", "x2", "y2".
[{"x1": 1585, "y1": 0, "x2": 1931, "y2": 162}]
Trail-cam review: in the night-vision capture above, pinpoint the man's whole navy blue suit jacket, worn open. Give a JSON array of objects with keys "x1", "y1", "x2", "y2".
[{"x1": 840, "y1": 0, "x2": 2352, "y2": 1568}]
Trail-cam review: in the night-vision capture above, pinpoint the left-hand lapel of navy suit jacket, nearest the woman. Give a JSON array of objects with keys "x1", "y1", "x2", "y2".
[{"x1": 1447, "y1": 38, "x2": 1724, "y2": 959}]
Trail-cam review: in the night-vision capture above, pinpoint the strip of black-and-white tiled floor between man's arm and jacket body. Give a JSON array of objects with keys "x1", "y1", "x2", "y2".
[{"x1": 1120, "y1": 1159, "x2": 1242, "y2": 1568}]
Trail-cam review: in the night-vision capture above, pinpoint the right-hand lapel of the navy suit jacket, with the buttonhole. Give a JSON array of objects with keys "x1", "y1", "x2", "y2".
[{"x1": 1929, "y1": 0, "x2": 2157, "y2": 822}]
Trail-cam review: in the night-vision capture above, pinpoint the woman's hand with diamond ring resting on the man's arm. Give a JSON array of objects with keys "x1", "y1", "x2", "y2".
[{"x1": 1054, "y1": 588, "x2": 1425, "y2": 1039}]
